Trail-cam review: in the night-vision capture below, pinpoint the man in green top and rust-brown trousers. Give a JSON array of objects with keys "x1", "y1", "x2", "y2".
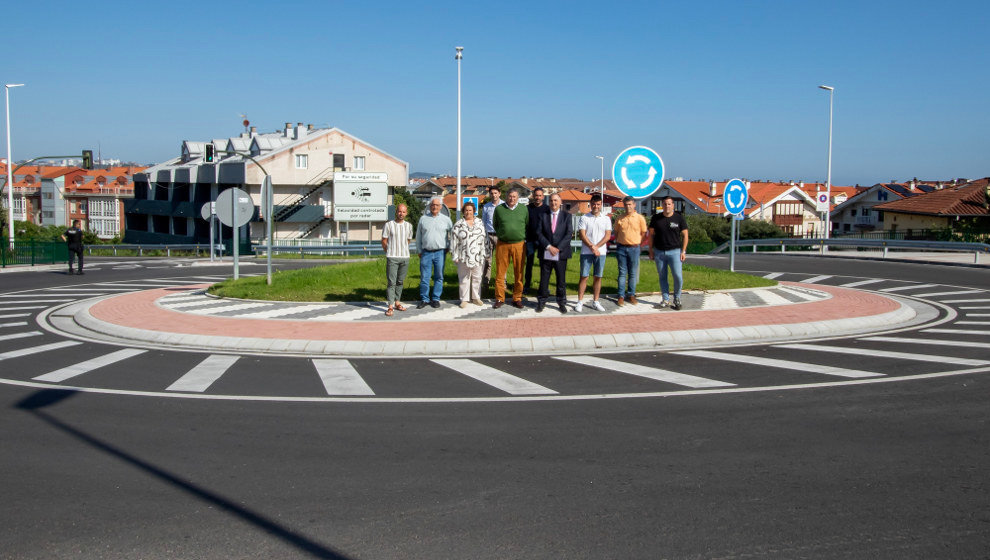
[{"x1": 492, "y1": 189, "x2": 529, "y2": 309}]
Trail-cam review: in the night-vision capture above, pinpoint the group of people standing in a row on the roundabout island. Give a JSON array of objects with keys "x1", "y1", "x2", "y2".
[{"x1": 382, "y1": 186, "x2": 688, "y2": 316}]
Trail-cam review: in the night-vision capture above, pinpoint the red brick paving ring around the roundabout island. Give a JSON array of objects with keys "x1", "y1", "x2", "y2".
[{"x1": 90, "y1": 282, "x2": 900, "y2": 341}]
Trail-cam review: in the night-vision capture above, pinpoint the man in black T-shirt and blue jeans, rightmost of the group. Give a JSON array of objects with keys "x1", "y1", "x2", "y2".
[{"x1": 650, "y1": 196, "x2": 688, "y2": 311}]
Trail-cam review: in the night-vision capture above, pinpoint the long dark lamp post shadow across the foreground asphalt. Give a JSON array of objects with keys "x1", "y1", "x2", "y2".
[{"x1": 15, "y1": 389, "x2": 349, "y2": 560}]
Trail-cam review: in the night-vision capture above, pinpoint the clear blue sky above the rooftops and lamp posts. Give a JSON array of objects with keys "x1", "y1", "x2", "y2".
[{"x1": 0, "y1": 1, "x2": 990, "y2": 184}]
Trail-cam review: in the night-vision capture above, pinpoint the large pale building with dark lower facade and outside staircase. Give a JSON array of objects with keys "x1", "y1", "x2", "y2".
[{"x1": 125, "y1": 123, "x2": 409, "y2": 243}]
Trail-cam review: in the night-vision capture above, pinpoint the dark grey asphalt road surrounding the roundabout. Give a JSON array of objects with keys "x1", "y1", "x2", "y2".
[{"x1": 0, "y1": 255, "x2": 990, "y2": 558}]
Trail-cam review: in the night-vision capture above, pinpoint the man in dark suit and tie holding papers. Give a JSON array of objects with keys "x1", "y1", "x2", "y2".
[{"x1": 536, "y1": 194, "x2": 574, "y2": 313}]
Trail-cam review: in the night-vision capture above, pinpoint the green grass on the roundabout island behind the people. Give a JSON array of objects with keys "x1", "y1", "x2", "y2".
[{"x1": 209, "y1": 255, "x2": 777, "y2": 301}]
